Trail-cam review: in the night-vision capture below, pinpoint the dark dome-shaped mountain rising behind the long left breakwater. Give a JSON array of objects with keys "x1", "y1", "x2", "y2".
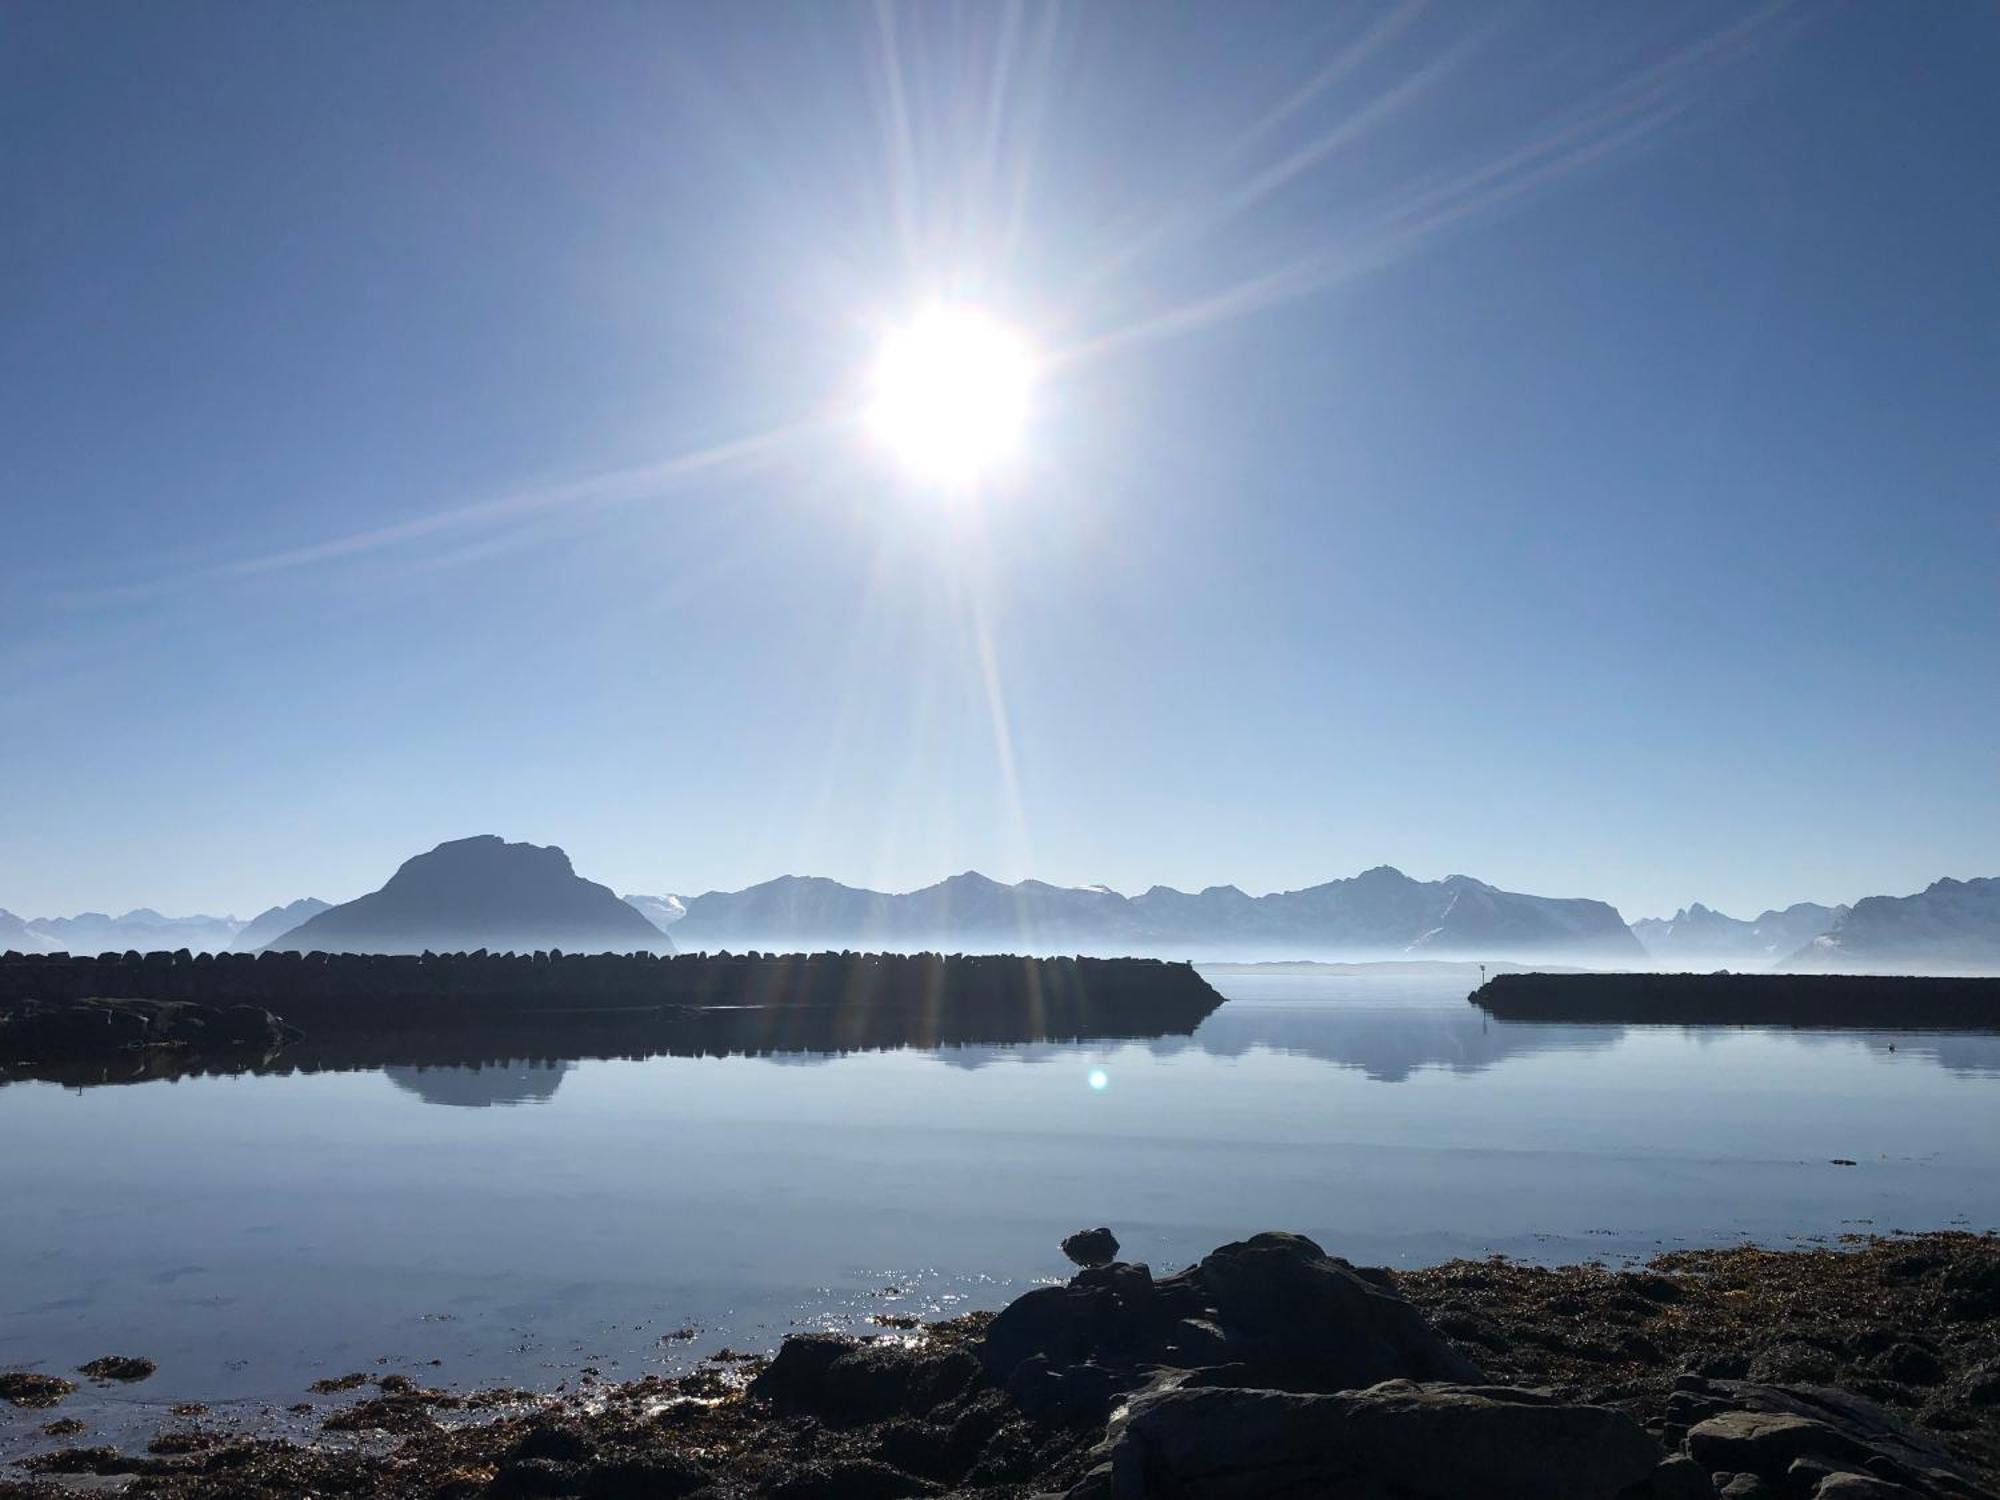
[{"x1": 270, "y1": 834, "x2": 672, "y2": 954}]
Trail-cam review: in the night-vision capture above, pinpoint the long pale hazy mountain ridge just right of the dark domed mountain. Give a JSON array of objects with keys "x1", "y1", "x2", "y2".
[{"x1": 674, "y1": 866, "x2": 1644, "y2": 962}]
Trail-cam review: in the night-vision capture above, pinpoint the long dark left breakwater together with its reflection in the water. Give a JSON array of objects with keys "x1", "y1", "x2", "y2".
[{"x1": 0, "y1": 952, "x2": 1222, "y2": 1082}]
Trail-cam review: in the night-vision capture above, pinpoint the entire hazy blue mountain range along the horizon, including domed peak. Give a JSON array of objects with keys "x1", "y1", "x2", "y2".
[{"x1": 15, "y1": 834, "x2": 2000, "y2": 972}]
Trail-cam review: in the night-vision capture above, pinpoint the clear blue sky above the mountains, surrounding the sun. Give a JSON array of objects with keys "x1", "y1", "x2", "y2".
[{"x1": 0, "y1": 2, "x2": 2000, "y2": 918}]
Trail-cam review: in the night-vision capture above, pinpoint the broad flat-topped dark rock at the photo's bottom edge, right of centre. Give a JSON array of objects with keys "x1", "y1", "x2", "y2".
[{"x1": 1070, "y1": 1380, "x2": 1660, "y2": 1500}]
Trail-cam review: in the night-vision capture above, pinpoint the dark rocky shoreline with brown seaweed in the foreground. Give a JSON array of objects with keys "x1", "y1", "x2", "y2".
[{"x1": 0, "y1": 1232, "x2": 2000, "y2": 1500}]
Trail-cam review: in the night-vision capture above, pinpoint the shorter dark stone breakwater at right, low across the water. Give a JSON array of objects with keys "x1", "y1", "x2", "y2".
[{"x1": 1472, "y1": 974, "x2": 2000, "y2": 1030}]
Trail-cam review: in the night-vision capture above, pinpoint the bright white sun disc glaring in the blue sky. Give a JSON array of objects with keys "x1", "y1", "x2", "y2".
[{"x1": 868, "y1": 302, "x2": 1036, "y2": 492}]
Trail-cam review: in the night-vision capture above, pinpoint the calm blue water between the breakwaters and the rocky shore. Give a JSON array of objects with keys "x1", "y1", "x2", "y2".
[{"x1": 0, "y1": 976, "x2": 2000, "y2": 1452}]
